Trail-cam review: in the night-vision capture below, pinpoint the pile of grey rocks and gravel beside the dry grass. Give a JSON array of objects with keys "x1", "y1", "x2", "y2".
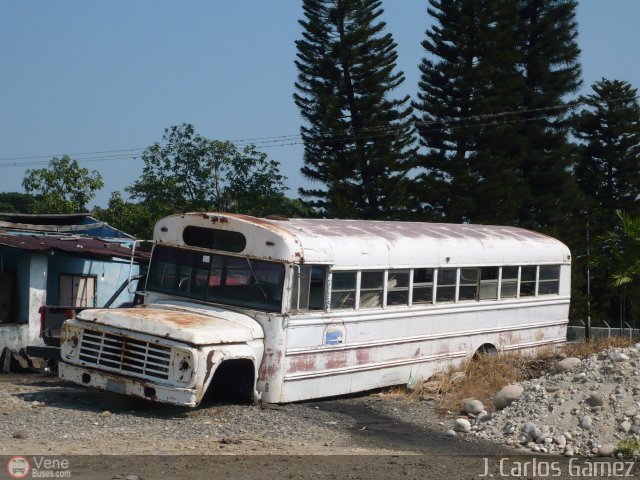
[{"x1": 447, "y1": 343, "x2": 640, "y2": 456}]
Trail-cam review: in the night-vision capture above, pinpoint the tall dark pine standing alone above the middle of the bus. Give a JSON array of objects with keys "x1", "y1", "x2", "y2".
[{"x1": 294, "y1": 0, "x2": 417, "y2": 218}]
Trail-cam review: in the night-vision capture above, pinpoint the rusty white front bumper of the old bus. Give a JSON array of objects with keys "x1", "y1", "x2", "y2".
[{"x1": 58, "y1": 362, "x2": 198, "y2": 407}]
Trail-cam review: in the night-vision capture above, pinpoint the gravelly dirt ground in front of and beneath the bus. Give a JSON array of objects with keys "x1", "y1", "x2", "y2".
[{"x1": 0, "y1": 374, "x2": 637, "y2": 480}]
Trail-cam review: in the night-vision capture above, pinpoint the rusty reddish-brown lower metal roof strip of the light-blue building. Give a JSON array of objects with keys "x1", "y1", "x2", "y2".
[{"x1": 0, "y1": 233, "x2": 149, "y2": 263}]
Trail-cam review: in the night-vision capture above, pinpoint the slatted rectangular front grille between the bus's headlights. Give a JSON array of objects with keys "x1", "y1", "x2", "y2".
[{"x1": 79, "y1": 330, "x2": 171, "y2": 380}]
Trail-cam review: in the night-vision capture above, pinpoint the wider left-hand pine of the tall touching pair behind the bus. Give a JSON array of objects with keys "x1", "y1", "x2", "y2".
[{"x1": 414, "y1": 0, "x2": 524, "y2": 223}]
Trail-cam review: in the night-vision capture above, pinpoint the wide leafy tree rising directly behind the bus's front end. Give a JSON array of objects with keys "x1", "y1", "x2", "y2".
[{"x1": 126, "y1": 124, "x2": 286, "y2": 217}]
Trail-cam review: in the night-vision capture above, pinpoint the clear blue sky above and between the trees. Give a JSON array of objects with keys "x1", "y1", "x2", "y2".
[{"x1": 0, "y1": 0, "x2": 640, "y2": 205}]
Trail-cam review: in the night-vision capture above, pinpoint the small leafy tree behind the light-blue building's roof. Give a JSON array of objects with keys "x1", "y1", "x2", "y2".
[{"x1": 22, "y1": 155, "x2": 104, "y2": 213}]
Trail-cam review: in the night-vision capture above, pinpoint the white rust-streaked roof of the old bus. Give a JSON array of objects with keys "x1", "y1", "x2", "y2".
[{"x1": 154, "y1": 213, "x2": 571, "y2": 268}]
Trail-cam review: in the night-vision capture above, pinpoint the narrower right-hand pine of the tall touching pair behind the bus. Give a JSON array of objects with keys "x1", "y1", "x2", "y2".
[{"x1": 517, "y1": 0, "x2": 582, "y2": 237}]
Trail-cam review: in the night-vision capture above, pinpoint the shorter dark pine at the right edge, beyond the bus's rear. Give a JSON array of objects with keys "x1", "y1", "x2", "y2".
[{"x1": 573, "y1": 79, "x2": 640, "y2": 323}]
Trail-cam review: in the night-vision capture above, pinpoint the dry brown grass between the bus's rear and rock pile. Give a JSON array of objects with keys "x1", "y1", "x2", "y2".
[{"x1": 411, "y1": 337, "x2": 633, "y2": 413}]
